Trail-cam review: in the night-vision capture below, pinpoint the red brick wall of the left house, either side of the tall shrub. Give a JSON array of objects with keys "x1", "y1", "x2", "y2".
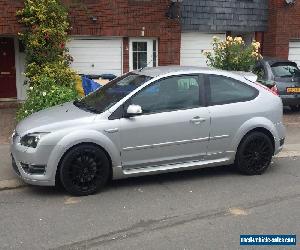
[{"x1": 0, "y1": 0, "x2": 181, "y2": 71}]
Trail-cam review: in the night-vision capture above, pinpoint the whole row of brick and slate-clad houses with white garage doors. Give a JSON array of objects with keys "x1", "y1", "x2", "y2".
[{"x1": 0, "y1": 0, "x2": 300, "y2": 101}]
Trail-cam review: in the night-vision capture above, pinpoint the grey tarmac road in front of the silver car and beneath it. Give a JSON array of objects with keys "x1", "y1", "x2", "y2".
[{"x1": 0, "y1": 157, "x2": 300, "y2": 250}]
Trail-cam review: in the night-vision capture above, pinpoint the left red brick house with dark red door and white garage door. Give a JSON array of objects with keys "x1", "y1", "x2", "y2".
[{"x1": 0, "y1": 0, "x2": 181, "y2": 100}]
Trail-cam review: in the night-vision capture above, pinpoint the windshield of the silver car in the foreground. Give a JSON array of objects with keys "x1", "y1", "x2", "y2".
[{"x1": 74, "y1": 73, "x2": 151, "y2": 113}]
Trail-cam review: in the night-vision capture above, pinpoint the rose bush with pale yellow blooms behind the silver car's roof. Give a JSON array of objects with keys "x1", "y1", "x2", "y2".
[{"x1": 203, "y1": 36, "x2": 262, "y2": 71}]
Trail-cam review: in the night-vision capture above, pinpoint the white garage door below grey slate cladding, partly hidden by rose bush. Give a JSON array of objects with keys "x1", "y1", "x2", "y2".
[{"x1": 180, "y1": 32, "x2": 226, "y2": 67}]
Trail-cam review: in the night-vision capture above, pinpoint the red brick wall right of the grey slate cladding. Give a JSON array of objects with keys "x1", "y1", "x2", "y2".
[{"x1": 264, "y1": 0, "x2": 300, "y2": 58}]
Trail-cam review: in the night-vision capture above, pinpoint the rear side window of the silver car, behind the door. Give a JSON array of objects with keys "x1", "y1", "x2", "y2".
[{"x1": 209, "y1": 75, "x2": 258, "y2": 105}]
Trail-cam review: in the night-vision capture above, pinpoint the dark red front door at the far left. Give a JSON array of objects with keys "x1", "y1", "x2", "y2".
[{"x1": 0, "y1": 37, "x2": 17, "y2": 98}]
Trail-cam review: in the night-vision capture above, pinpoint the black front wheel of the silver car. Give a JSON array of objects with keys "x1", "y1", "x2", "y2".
[{"x1": 59, "y1": 144, "x2": 111, "y2": 196}]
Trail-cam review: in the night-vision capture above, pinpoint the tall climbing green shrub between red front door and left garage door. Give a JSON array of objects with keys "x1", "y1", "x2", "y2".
[{"x1": 17, "y1": 0, "x2": 77, "y2": 121}]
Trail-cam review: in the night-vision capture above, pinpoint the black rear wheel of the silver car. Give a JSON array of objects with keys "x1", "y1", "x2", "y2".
[{"x1": 235, "y1": 132, "x2": 274, "y2": 175}]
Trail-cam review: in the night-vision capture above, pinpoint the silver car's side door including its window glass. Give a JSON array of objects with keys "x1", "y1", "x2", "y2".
[{"x1": 120, "y1": 75, "x2": 210, "y2": 169}]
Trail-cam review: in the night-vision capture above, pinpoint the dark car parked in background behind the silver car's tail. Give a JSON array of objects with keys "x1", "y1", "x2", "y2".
[{"x1": 254, "y1": 57, "x2": 300, "y2": 111}]
